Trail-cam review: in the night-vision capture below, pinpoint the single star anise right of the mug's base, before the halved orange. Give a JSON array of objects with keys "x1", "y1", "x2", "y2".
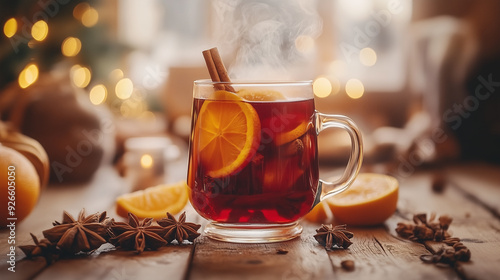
[{"x1": 314, "y1": 225, "x2": 354, "y2": 250}]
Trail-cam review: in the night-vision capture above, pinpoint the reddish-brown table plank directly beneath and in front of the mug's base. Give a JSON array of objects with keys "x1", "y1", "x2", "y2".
[{"x1": 188, "y1": 227, "x2": 333, "y2": 280}]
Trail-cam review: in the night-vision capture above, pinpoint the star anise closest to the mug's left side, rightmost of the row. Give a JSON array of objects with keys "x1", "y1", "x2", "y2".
[{"x1": 158, "y1": 212, "x2": 201, "y2": 244}]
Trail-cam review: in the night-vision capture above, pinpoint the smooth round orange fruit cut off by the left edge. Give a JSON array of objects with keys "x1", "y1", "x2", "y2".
[{"x1": 0, "y1": 144, "x2": 40, "y2": 228}]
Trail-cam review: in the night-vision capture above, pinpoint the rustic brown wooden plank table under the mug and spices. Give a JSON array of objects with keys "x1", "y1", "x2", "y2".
[{"x1": 0, "y1": 158, "x2": 500, "y2": 280}]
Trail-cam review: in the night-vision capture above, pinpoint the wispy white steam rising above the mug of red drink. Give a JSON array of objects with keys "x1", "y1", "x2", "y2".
[{"x1": 214, "y1": 0, "x2": 322, "y2": 80}]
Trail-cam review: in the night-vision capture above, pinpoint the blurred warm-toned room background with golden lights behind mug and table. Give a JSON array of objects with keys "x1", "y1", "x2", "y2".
[{"x1": 0, "y1": 0, "x2": 500, "y2": 186}]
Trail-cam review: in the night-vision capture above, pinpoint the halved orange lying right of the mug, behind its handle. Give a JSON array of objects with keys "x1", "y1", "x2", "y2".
[{"x1": 326, "y1": 173, "x2": 399, "y2": 226}]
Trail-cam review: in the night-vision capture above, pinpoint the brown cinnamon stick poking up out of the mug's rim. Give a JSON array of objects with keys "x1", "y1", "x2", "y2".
[{"x1": 203, "y1": 48, "x2": 235, "y2": 92}]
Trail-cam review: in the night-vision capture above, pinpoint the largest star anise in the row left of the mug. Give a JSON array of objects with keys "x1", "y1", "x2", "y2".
[{"x1": 43, "y1": 209, "x2": 110, "y2": 254}]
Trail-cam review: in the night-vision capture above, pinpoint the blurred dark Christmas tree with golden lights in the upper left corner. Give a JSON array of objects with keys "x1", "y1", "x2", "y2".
[{"x1": 0, "y1": 0, "x2": 127, "y2": 104}]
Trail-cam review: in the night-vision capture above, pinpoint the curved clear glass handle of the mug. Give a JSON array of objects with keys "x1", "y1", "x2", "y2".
[{"x1": 311, "y1": 111, "x2": 363, "y2": 209}]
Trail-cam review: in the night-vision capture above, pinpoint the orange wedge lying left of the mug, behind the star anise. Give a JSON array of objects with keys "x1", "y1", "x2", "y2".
[{"x1": 116, "y1": 181, "x2": 188, "y2": 219}]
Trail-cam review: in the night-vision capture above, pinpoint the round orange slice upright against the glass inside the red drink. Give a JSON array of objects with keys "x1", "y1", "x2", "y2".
[{"x1": 193, "y1": 91, "x2": 260, "y2": 178}]
